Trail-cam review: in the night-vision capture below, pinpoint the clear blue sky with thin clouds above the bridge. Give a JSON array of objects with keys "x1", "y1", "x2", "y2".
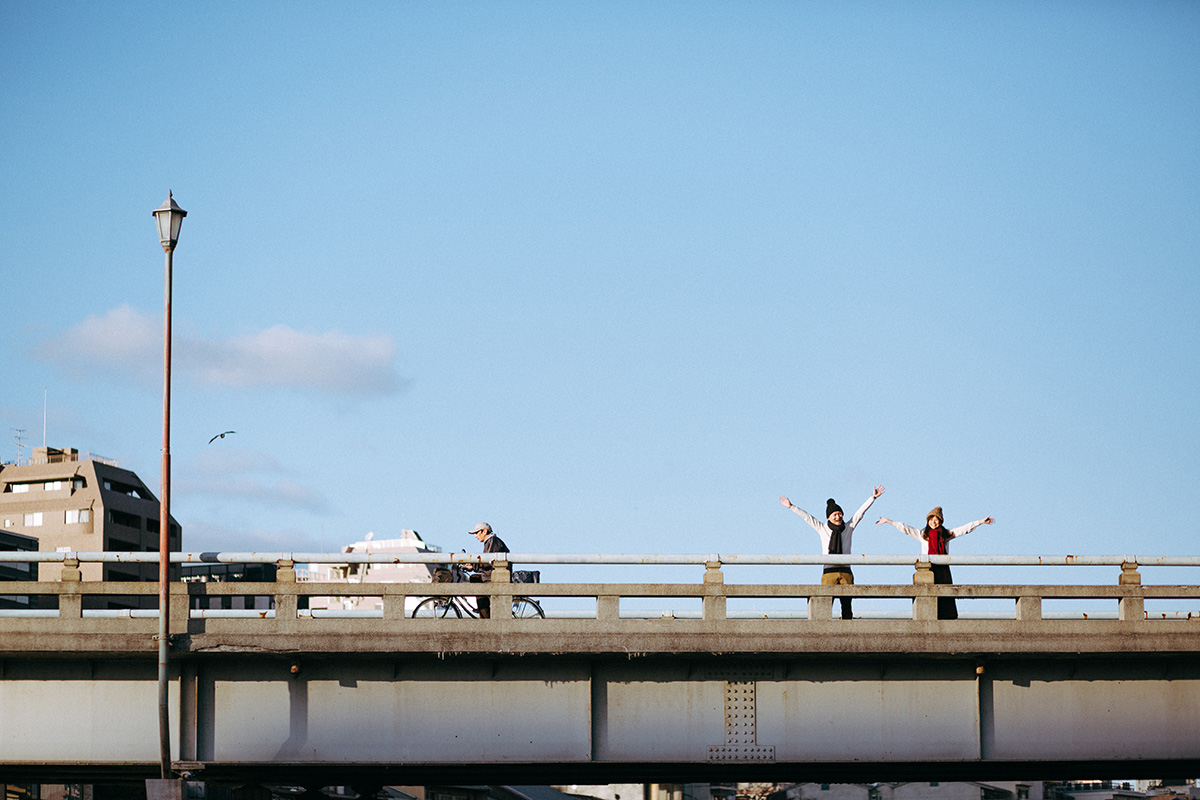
[{"x1": 0, "y1": 0, "x2": 1200, "y2": 585}]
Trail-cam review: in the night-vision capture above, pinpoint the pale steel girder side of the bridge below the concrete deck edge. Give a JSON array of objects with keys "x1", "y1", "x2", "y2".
[{"x1": 0, "y1": 652, "x2": 1200, "y2": 786}]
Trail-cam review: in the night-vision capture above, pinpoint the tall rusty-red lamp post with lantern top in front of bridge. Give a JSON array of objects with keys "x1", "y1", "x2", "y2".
[{"x1": 154, "y1": 192, "x2": 187, "y2": 781}]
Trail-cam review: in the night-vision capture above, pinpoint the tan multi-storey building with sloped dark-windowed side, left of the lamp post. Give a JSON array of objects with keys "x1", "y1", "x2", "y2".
[{"x1": 0, "y1": 447, "x2": 182, "y2": 607}]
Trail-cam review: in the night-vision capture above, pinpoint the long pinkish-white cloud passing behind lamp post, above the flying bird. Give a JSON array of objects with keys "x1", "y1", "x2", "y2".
[{"x1": 34, "y1": 306, "x2": 403, "y2": 396}]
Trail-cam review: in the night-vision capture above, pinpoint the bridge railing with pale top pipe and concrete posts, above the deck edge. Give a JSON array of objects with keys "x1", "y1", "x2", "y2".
[{"x1": 0, "y1": 552, "x2": 1200, "y2": 627}]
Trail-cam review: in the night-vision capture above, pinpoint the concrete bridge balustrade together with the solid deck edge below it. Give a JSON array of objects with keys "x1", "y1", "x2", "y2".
[{"x1": 0, "y1": 553, "x2": 1200, "y2": 654}]
